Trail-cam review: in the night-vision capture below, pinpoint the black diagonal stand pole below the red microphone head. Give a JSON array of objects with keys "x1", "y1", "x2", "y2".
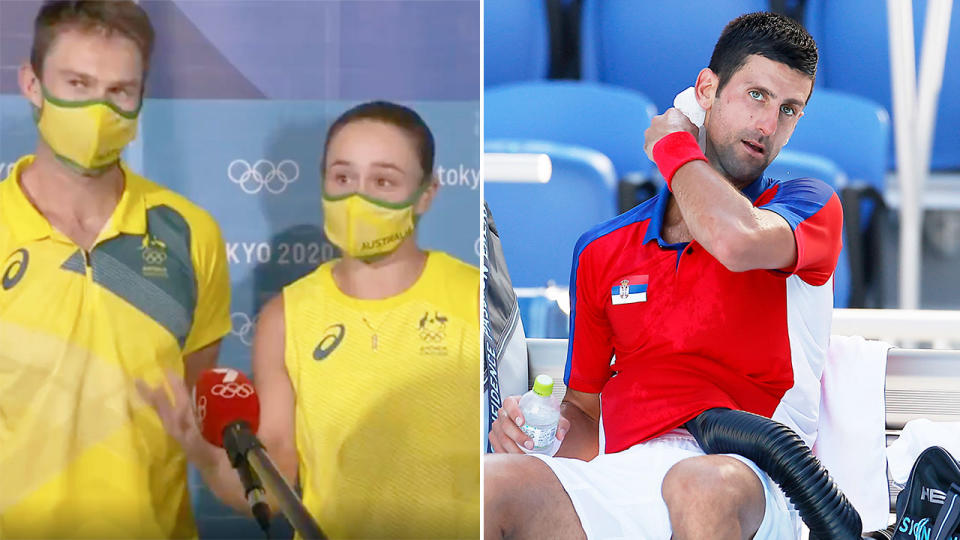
[{"x1": 223, "y1": 422, "x2": 327, "y2": 540}]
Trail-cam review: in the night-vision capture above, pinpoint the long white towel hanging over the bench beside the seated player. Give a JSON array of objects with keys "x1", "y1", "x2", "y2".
[{"x1": 813, "y1": 336, "x2": 890, "y2": 531}]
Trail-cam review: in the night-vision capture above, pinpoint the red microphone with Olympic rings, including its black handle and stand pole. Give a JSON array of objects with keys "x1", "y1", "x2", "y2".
[{"x1": 193, "y1": 368, "x2": 327, "y2": 540}]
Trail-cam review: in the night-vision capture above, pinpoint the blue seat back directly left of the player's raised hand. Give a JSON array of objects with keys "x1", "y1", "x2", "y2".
[{"x1": 484, "y1": 81, "x2": 656, "y2": 178}]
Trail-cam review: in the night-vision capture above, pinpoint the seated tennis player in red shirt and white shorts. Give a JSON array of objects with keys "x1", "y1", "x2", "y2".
[{"x1": 484, "y1": 13, "x2": 843, "y2": 540}]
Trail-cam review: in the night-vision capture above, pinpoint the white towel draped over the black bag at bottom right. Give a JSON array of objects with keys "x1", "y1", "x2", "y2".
[{"x1": 887, "y1": 418, "x2": 960, "y2": 486}]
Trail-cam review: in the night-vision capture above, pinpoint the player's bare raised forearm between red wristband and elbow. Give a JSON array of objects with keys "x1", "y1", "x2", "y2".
[{"x1": 671, "y1": 160, "x2": 759, "y2": 269}]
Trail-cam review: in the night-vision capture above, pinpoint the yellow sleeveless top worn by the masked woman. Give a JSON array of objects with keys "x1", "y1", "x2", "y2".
[{"x1": 283, "y1": 251, "x2": 482, "y2": 538}]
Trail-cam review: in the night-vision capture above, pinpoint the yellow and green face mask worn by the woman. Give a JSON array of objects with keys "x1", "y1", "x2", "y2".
[{"x1": 323, "y1": 182, "x2": 430, "y2": 261}]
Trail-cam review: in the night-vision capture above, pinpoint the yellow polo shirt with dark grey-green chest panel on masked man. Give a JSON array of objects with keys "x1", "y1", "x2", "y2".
[{"x1": 0, "y1": 156, "x2": 230, "y2": 538}]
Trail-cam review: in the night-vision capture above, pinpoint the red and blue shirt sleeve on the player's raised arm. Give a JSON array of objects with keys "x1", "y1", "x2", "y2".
[{"x1": 758, "y1": 178, "x2": 843, "y2": 285}]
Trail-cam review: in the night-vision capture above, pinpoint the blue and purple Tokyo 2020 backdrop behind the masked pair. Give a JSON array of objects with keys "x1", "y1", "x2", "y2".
[{"x1": 0, "y1": 0, "x2": 481, "y2": 537}]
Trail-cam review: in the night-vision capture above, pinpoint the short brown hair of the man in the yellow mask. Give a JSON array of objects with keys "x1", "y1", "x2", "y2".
[{"x1": 30, "y1": 0, "x2": 154, "y2": 77}]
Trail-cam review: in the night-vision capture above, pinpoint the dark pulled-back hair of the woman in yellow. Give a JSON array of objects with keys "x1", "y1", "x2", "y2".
[{"x1": 321, "y1": 101, "x2": 435, "y2": 182}]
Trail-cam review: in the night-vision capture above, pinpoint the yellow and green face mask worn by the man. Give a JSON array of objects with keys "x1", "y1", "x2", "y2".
[{"x1": 34, "y1": 88, "x2": 143, "y2": 176}]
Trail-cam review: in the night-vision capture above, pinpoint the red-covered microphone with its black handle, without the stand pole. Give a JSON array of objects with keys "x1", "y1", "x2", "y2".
[{"x1": 193, "y1": 368, "x2": 270, "y2": 536}]
